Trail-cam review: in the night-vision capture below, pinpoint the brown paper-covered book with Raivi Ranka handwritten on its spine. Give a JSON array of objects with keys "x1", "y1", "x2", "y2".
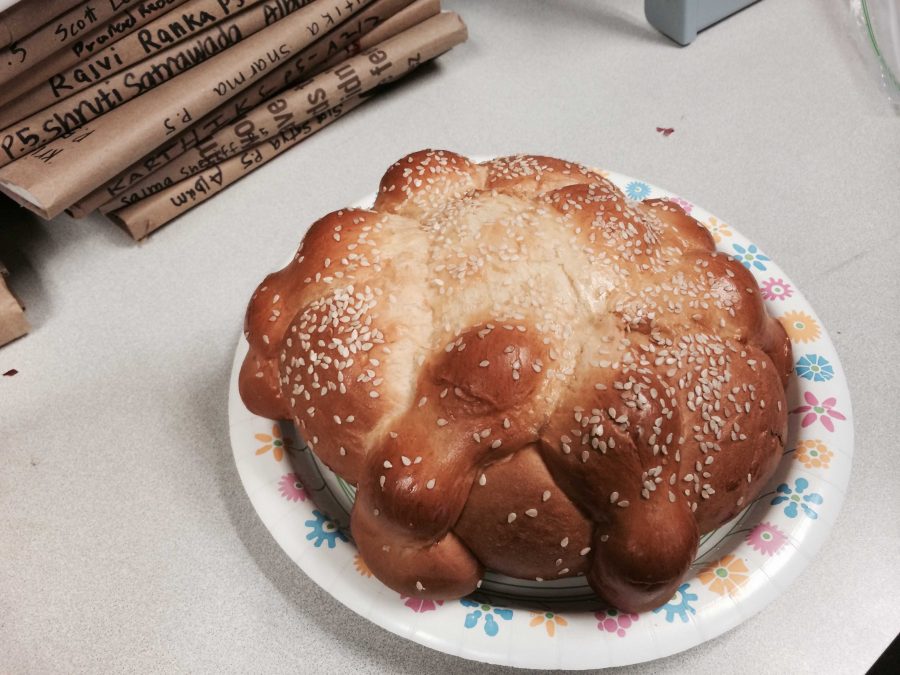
[{"x1": 0, "y1": 0, "x2": 243, "y2": 129}]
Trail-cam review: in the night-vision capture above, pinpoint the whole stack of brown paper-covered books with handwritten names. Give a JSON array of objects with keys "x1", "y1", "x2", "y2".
[{"x1": 0, "y1": 0, "x2": 467, "y2": 239}]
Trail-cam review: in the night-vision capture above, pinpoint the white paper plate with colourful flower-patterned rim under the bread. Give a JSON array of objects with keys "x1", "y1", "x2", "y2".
[{"x1": 228, "y1": 166, "x2": 853, "y2": 669}]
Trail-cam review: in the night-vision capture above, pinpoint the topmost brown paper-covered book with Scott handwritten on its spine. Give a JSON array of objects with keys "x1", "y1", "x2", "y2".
[{"x1": 0, "y1": 0, "x2": 148, "y2": 85}]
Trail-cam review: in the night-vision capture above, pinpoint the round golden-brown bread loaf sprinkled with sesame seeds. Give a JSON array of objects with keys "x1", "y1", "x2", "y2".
[{"x1": 240, "y1": 151, "x2": 791, "y2": 611}]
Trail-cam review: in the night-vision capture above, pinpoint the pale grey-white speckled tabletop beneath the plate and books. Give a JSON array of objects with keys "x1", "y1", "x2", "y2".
[{"x1": 0, "y1": 0, "x2": 900, "y2": 673}]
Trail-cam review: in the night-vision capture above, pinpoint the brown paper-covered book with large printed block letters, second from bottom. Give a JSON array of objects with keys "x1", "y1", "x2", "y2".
[{"x1": 108, "y1": 7, "x2": 465, "y2": 211}]
